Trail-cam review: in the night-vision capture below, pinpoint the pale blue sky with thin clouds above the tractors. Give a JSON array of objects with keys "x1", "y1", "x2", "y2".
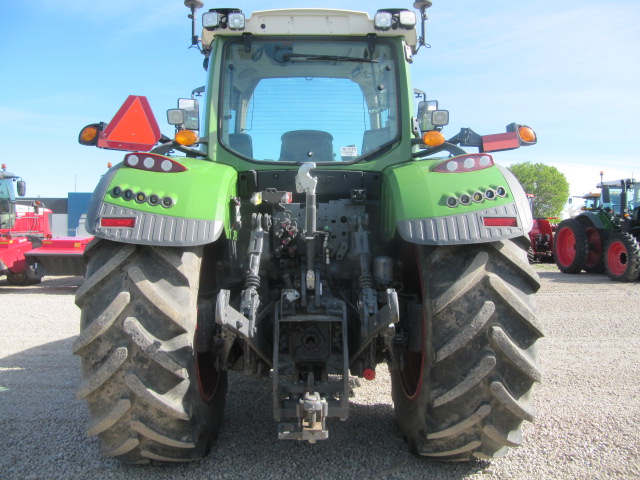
[{"x1": 0, "y1": 0, "x2": 640, "y2": 197}]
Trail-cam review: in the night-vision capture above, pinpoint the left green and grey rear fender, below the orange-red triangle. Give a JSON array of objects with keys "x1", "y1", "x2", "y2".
[{"x1": 85, "y1": 157, "x2": 237, "y2": 246}]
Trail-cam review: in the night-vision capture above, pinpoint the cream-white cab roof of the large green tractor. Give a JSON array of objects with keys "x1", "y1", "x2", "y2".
[{"x1": 202, "y1": 8, "x2": 418, "y2": 50}]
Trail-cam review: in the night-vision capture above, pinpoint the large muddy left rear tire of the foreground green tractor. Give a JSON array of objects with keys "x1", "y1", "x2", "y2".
[{"x1": 73, "y1": 240, "x2": 227, "y2": 463}]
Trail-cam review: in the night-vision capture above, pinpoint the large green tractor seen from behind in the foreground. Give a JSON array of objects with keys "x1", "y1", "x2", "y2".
[{"x1": 74, "y1": 0, "x2": 542, "y2": 463}]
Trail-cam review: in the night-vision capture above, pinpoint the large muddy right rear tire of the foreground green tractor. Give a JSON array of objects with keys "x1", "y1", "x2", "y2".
[{"x1": 390, "y1": 237, "x2": 542, "y2": 460}]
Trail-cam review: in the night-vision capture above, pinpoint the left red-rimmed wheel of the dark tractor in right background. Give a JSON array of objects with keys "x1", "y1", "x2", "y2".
[{"x1": 553, "y1": 218, "x2": 588, "y2": 273}]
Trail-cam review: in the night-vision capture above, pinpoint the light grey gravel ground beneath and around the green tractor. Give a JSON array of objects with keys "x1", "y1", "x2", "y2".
[{"x1": 0, "y1": 265, "x2": 640, "y2": 480}]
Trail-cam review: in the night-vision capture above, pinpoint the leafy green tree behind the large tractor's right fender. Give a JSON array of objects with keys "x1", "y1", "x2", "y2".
[{"x1": 508, "y1": 162, "x2": 569, "y2": 217}]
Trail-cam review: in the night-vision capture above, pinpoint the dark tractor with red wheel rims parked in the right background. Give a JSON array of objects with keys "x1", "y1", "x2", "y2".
[{"x1": 554, "y1": 178, "x2": 640, "y2": 282}]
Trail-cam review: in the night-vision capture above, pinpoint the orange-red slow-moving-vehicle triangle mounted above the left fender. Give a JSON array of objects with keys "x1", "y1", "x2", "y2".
[{"x1": 104, "y1": 95, "x2": 160, "y2": 152}]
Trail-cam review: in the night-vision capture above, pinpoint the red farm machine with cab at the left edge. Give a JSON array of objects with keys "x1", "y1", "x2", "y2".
[{"x1": 0, "y1": 164, "x2": 91, "y2": 286}]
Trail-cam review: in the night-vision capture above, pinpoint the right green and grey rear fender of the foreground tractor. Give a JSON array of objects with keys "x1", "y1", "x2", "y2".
[{"x1": 383, "y1": 159, "x2": 533, "y2": 245}]
